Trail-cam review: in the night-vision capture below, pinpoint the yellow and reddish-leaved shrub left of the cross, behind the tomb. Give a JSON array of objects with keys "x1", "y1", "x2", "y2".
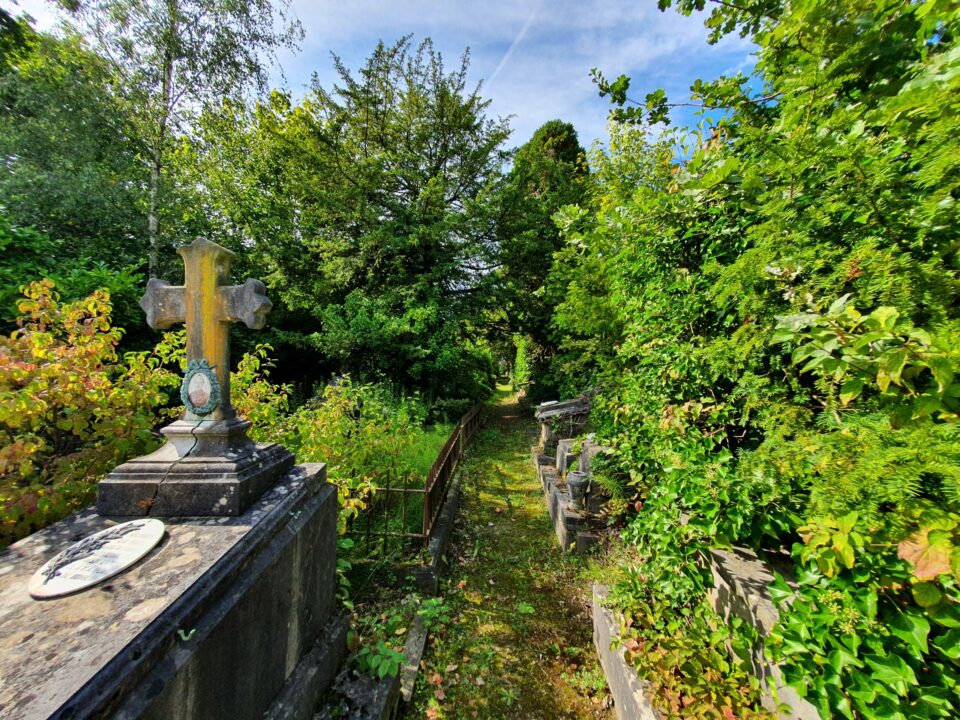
[{"x1": 0, "y1": 280, "x2": 182, "y2": 545}]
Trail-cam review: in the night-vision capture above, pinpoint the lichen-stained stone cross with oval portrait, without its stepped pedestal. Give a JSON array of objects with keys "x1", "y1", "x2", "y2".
[{"x1": 140, "y1": 238, "x2": 273, "y2": 420}]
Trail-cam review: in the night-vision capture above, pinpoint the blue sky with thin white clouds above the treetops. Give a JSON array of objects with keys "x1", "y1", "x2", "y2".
[{"x1": 11, "y1": 0, "x2": 752, "y2": 146}]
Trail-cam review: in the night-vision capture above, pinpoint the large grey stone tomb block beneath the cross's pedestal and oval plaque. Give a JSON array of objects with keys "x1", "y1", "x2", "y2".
[{"x1": 0, "y1": 465, "x2": 346, "y2": 720}]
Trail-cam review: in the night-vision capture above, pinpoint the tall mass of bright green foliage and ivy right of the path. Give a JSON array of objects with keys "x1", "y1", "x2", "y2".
[{"x1": 551, "y1": 0, "x2": 960, "y2": 717}]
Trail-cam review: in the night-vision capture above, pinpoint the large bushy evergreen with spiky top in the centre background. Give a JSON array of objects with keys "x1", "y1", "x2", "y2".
[{"x1": 193, "y1": 38, "x2": 509, "y2": 396}]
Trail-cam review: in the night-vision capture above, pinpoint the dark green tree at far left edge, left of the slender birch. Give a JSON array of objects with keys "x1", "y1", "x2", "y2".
[{"x1": 0, "y1": 23, "x2": 146, "y2": 267}]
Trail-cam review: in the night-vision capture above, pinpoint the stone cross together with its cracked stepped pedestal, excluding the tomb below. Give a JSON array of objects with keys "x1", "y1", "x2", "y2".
[{"x1": 97, "y1": 238, "x2": 293, "y2": 516}]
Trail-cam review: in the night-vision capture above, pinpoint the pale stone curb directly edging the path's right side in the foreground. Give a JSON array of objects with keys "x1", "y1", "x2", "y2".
[{"x1": 592, "y1": 584, "x2": 661, "y2": 720}]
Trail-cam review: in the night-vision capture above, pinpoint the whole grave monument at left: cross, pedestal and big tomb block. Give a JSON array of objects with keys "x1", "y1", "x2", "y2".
[{"x1": 0, "y1": 241, "x2": 347, "y2": 720}]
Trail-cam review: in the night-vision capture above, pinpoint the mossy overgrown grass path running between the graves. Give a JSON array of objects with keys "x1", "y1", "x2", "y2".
[{"x1": 405, "y1": 393, "x2": 614, "y2": 720}]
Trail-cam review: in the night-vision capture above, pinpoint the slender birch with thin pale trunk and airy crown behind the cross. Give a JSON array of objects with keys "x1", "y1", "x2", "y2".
[{"x1": 63, "y1": 0, "x2": 302, "y2": 276}]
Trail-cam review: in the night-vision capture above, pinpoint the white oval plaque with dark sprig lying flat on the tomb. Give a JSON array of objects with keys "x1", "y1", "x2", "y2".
[{"x1": 27, "y1": 518, "x2": 164, "y2": 598}]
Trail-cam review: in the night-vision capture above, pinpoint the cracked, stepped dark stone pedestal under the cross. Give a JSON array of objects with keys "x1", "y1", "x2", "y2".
[{"x1": 97, "y1": 418, "x2": 294, "y2": 517}]
